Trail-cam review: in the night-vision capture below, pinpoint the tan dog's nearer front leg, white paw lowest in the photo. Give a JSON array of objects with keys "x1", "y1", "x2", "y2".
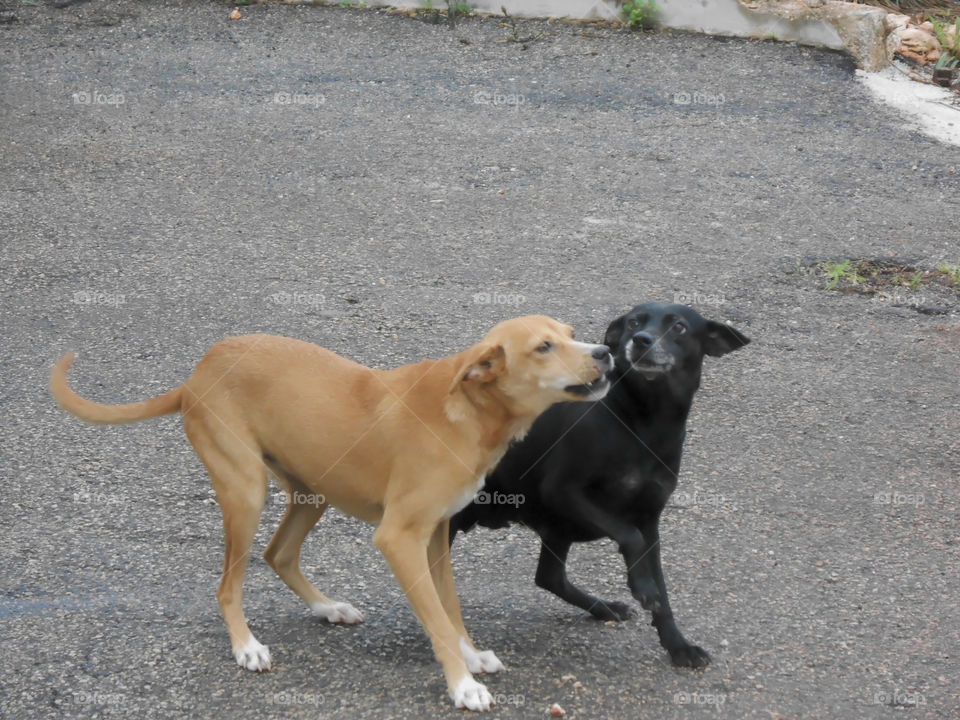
[{"x1": 373, "y1": 514, "x2": 493, "y2": 710}]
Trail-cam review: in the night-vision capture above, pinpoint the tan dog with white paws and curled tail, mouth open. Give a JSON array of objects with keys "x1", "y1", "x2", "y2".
[{"x1": 50, "y1": 315, "x2": 612, "y2": 710}]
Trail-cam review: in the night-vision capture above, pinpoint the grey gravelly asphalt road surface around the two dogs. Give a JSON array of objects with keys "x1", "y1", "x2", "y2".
[{"x1": 0, "y1": 1, "x2": 960, "y2": 720}]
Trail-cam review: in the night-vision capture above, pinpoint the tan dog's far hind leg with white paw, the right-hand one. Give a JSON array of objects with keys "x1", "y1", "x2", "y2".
[{"x1": 263, "y1": 486, "x2": 363, "y2": 625}]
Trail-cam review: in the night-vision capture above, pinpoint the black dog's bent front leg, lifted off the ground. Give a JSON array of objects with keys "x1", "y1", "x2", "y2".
[{"x1": 545, "y1": 488, "x2": 661, "y2": 612}]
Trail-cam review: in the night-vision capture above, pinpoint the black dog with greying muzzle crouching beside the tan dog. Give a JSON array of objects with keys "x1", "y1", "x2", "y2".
[{"x1": 450, "y1": 303, "x2": 750, "y2": 667}]
